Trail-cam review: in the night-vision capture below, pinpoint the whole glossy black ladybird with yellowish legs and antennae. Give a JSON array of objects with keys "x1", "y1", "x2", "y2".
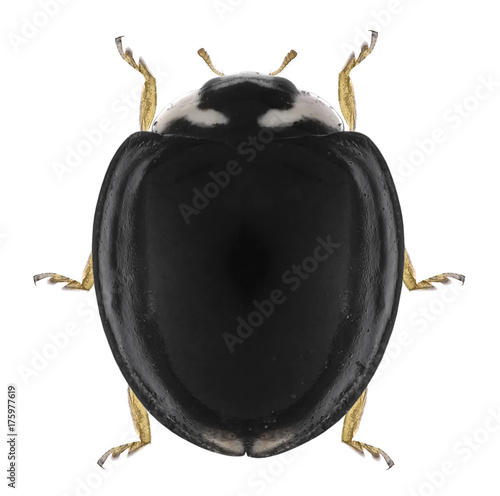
[{"x1": 35, "y1": 32, "x2": 464, "y2": 466}]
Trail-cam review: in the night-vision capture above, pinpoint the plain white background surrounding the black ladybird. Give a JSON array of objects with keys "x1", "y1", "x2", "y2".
[{"x1": 0, "y1": 0, "x2": 500, "y2": 496}]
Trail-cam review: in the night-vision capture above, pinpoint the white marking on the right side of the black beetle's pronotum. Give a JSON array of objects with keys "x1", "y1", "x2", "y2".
[{"x1": 257, "y1": 91, "x2": 344, "y2": 131}]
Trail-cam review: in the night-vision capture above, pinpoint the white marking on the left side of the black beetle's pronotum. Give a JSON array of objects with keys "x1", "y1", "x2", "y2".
[{"x1": 152, "y1": 90, "x2": 229, "y2": 134}]
